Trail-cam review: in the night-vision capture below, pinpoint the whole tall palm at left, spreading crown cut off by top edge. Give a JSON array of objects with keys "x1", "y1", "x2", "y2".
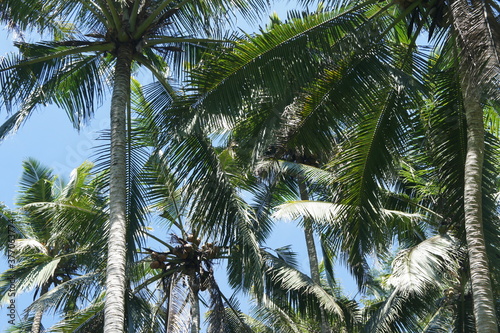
[{"x1": 0, "y1": 0, "x2": 270, "y2": 332}]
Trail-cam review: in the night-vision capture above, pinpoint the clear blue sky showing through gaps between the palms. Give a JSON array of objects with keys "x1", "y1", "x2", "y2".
[{"x1": 0, "y1": 2, "x2": 356, "y2": 332}]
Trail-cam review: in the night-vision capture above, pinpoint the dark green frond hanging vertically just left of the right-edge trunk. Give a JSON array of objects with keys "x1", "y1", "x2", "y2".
[{"x1": 421, "y1": 41, "x2": 466, "y2": 228}]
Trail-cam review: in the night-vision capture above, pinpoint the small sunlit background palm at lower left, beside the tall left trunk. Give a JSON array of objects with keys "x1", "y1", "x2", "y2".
[{"x1": 0, "y1": 159, "x2": 106, "y2": 333}]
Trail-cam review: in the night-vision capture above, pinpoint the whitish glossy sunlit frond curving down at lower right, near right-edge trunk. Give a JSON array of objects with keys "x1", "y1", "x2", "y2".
[{"x1": 365, "y1": 234, "x2": 465, "y2": 332}]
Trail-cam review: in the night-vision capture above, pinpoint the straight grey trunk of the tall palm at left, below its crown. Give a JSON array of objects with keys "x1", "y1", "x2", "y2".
[{"x1": 104, "y1": 44, "x2": 132, "y2": 333}]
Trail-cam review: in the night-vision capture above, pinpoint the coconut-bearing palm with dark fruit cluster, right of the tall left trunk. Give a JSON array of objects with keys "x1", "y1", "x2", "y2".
[{"x1": 129, "y1": 132, "x2": 259, "y2": 333}]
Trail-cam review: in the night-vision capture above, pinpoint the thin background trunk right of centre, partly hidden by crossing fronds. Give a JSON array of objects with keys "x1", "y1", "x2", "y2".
[{"x1": 298, "y1": 178, "x2": 330, "y2": 333}]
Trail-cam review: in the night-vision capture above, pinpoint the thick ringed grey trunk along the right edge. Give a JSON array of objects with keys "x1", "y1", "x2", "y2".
[{"x1": 451, "y1": 0, "x2": 498, "y2": 333}]
